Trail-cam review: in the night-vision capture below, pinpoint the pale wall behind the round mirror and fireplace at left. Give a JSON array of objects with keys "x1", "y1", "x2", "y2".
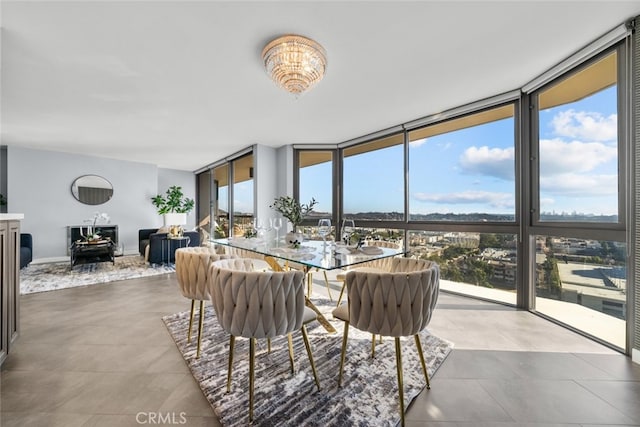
[{"x1": 7, "y1": 146, "x2": 195, "y2": 262}]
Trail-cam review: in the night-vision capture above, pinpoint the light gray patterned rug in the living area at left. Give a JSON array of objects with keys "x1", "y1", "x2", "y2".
[{"x1": 20, "y1": 255, "x2": 175, "y2": 295}]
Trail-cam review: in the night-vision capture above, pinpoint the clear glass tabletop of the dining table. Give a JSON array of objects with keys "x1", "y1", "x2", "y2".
[{"x1": 211, "y1": 237, "x2": 403, "y2": 270}]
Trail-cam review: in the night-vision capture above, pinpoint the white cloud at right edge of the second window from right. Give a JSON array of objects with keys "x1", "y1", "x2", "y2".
[{"x1": 459, "y1": 146, "x2": 514, "y2": 181}]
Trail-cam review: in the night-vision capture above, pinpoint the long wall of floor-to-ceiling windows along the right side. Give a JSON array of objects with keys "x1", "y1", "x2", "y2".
[{"x1": 286, "y1": 28, "x2": 632, "y2": 349}]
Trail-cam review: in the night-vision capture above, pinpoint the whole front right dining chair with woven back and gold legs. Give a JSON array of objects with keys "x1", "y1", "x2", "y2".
[{"x1": 333, "y1": 258, "x2": 440, "y2": 426}]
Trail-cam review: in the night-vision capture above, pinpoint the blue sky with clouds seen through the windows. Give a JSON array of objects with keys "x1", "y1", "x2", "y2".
[{"x1": 301, "y1": 86, "x2": 618, "y2": 219}]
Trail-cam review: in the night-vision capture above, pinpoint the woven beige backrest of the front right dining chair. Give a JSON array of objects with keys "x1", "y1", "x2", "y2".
[{"x1": 346, "y1": 258, "x2": 440, "y2": 337}]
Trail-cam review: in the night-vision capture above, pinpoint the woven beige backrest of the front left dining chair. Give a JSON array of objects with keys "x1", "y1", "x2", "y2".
[{"x1": 209, "y1": 259, "x2": 305, "y2": 338}]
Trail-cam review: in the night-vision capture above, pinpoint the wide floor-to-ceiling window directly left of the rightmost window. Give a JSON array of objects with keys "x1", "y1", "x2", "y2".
[{"x1": 407, "y1": 103, "x2": 518, "y2": 304}]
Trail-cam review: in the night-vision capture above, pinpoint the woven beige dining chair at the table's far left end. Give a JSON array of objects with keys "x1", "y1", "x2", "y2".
[{"x1": 175, "y1": 246, "x2": 235, "y2": 358}]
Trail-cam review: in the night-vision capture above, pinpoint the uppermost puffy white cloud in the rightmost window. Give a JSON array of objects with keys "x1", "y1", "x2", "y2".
[{"x1": 551, "y1": 110, "x2": 618, "y2": 141}]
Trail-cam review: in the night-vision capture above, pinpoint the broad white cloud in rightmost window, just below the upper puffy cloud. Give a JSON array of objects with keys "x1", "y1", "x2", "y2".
[{"x1": 540, "y1": 138, "x2": 618, "y2": 177}]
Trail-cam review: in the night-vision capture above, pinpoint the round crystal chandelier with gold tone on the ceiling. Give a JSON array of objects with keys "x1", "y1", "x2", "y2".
[{"x1": 262, "y1": 34, "x2": 327, "y2": 95}]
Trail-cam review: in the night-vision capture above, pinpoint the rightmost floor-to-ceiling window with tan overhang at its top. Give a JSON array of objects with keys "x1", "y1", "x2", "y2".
[{"x1": 532, "y1": 49, "x2": 627, "y2": 348}]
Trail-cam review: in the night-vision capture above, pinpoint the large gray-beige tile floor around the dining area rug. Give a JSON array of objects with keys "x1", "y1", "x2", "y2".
[{"x1": 0, "y1": 274, "x2": 640, "y2": 427}]
